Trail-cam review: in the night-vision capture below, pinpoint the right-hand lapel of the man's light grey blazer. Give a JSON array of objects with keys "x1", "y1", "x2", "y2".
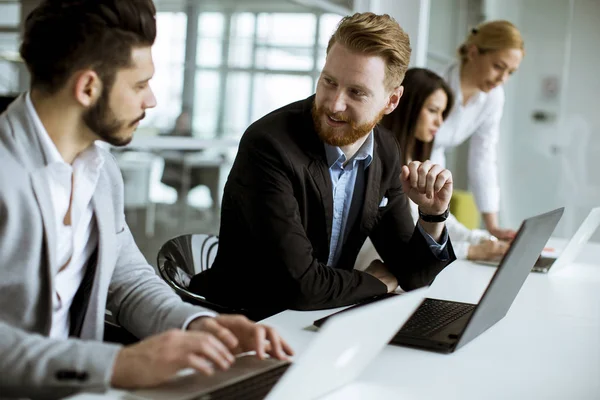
[{"x1": 80, "y1": 188, "x2": 117, "y2": 340}]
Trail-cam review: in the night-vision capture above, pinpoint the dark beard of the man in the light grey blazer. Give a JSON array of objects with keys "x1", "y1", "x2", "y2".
[{"x1": 83, "y1": 91, "x2": 146, "y2": 147}]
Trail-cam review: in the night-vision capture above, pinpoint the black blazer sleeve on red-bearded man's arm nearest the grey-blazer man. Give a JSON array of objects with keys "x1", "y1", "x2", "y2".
[{"x1": 228, "y1": 134, "x2": 386, "y2": 310}]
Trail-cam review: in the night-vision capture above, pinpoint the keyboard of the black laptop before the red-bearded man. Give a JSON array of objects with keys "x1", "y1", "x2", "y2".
[{"x1": 399, "y1": 299, "x2": 475, "y2": 336}]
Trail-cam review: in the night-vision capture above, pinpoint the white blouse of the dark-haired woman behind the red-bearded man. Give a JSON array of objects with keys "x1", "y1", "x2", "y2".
[{"x1": 354, "y1": 200, "x2": 492, "y2": 271}]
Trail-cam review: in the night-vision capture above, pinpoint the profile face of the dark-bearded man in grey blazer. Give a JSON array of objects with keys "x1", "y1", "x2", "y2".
[{"x1": 83, "y1": 47, "x2": 156, "y2": 146}]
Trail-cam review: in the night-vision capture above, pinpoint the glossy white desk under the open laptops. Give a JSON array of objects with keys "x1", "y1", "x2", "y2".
[{"x1": 65, "y1": 240, "x2": 600, "y2": 400}]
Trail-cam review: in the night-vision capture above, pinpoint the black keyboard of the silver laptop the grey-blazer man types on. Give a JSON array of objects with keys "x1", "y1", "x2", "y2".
[{"x1": 197, "y1": 364, "x2": 291, "y2": 400}]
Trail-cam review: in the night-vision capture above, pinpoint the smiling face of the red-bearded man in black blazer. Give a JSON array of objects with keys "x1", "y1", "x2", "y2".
[{"x1": 312, "y1": 43, "x2": 394, "y2": 146}]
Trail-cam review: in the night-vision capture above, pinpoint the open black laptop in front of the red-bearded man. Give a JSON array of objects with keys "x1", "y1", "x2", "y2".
[{"x1": 314, "y1": 208, "x2": 564, "y2": 353}]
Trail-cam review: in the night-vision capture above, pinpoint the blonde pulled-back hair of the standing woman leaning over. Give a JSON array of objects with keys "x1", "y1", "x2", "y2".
[{"x1": 458, "y1": 20, "x2": 525, "y2": 64}]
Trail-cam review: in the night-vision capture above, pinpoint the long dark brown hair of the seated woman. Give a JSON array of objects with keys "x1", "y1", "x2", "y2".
[{"x1": 380, "y1": 68, "x2": 454, "y2": 165}]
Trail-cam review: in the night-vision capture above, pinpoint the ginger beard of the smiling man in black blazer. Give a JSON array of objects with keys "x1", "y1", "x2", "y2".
[{"x1": 311, "y1": 102, "x2": 385, "y2": 147}]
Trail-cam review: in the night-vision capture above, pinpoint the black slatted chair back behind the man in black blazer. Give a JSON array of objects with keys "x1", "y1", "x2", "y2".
[{"x1": 157, "y1": 234, "x2": 252, "y2": 318}]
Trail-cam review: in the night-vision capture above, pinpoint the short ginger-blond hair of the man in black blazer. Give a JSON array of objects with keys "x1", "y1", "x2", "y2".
[{"x1": 327, "y1": 12, "x2": 411, "y2": 89}]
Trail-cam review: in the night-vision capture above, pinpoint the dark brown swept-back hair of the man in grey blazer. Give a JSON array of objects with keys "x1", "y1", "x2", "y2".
[{"x1": 20, "y1": 0, "x2": 156, "y2": 94}]
